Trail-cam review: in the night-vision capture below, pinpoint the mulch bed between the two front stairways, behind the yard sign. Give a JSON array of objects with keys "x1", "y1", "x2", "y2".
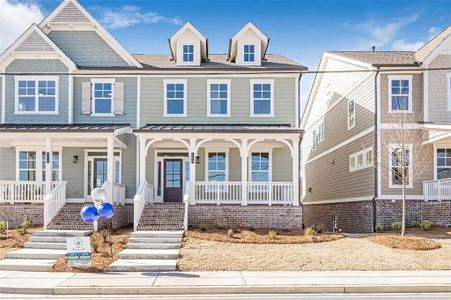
[{"x1": 52, "y1": 228, "x2": 133, "y2": 273}]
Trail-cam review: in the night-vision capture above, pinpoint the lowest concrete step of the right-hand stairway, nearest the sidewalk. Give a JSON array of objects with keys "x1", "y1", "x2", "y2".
[{"x1": 109, "y1": 259, "x2": 177, "y2": 272}]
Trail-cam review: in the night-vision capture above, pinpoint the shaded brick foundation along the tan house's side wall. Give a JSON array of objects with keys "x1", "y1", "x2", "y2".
[{"x1": 303, "y1": 201, "x2": 373, "y2": 233}]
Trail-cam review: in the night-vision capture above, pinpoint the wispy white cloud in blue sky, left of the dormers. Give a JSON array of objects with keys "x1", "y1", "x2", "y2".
[{"x1": 92, "y1": 5, "x2": 182, "y2": 29}]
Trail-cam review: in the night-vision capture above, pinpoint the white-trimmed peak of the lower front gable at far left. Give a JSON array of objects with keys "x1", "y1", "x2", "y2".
[{"x1": 0, "y1": 24, "x2": 77, "y2": 69}]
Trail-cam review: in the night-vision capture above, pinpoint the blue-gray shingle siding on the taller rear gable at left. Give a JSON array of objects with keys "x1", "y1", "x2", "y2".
[{"x1": 48, "y1": 31, "x2": 128, "y2": 67}]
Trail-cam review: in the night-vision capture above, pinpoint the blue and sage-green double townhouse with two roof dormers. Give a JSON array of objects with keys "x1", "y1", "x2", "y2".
[{"x1": 0, "y1": 0, "x2": 306, "y2": 229}]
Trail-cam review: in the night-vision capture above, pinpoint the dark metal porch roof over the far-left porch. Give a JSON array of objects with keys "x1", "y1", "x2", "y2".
[{"x1": 0, "y1": 124, "x2": 130, "y2": 132}]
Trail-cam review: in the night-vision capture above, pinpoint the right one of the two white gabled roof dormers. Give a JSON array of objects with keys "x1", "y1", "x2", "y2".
[{"x1": 229, "y1": 22, "x2": 269, "y2": 66}]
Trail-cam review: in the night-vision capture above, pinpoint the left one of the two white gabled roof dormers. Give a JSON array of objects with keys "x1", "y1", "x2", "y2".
[{"x1": 169, "y1": 22, "x2": 208, "y2": 66}]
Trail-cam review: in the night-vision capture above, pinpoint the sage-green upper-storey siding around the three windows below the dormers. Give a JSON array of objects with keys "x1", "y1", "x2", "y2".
[{"x1": 141, "y1": 77, "x2": 296, "y2": 125}]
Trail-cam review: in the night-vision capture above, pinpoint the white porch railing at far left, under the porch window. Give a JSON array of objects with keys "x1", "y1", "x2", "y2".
[{"x1": 0, "y1": 181, "x2": 60, "y2": 203}]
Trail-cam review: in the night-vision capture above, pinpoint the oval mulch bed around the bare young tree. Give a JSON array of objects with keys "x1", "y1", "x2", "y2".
[{"x1": 368, "y1": 235, "x2": 441, "y2": 251}]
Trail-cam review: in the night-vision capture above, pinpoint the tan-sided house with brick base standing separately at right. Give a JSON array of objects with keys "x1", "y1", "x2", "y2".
[{"x1": 301, "y1": 27, "x2": 451, "y2": 232}]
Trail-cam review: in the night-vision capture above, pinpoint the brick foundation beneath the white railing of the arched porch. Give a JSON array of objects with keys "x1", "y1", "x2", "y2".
[{"x1": 188, "y1": 204, "x2": 302, "y2": 229}]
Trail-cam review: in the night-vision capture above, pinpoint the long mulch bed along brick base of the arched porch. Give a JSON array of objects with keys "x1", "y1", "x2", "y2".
[{"x1": 185, "y1": 229, "x2": 343, "y2": 244}]
